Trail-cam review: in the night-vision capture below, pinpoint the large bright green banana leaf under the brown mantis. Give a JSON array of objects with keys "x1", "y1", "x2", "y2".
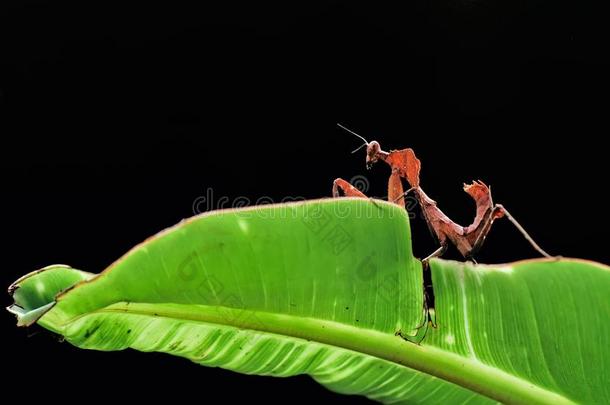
[{"x1": 9, "y1": 198, "x2": 610, "y2": 404}]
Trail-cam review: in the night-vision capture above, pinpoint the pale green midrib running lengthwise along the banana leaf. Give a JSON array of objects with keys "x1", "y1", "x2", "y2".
[{"x1": 45, "y1": 302, "x2": 574, "y2": 404}]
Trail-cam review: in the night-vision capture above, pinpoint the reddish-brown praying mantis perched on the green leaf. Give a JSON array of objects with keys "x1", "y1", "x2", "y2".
[{"x1": 333, "y1": 124, "x2": 551, "y2": 264}]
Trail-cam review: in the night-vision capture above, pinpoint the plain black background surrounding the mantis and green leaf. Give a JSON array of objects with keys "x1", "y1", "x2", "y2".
[{"x1": 0, "y1": 0, "x2": 610, "y2": 403}]
